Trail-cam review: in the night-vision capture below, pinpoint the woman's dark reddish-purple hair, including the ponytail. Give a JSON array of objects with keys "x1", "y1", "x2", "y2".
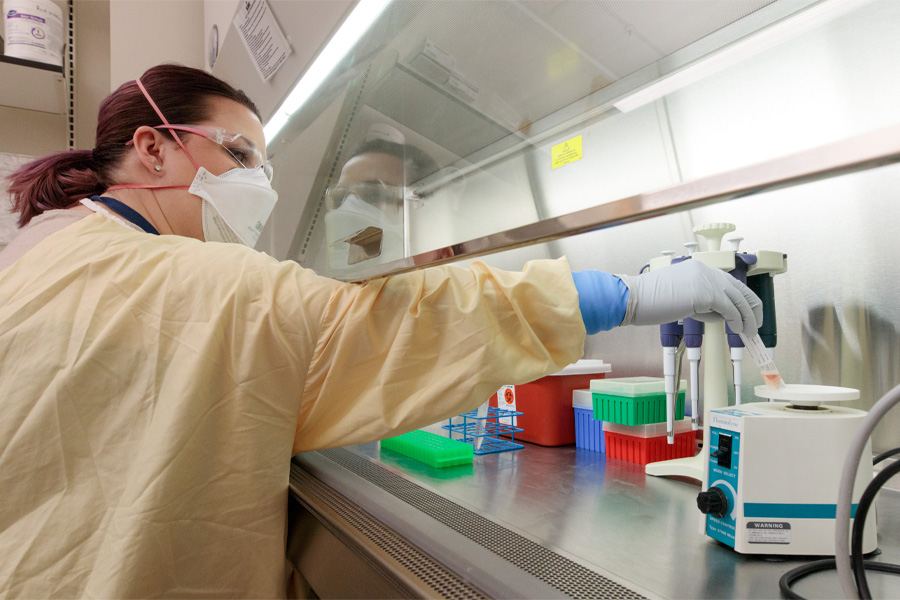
[{"x1": 8, "y1": 64, "x2": 261, "y2": 227}]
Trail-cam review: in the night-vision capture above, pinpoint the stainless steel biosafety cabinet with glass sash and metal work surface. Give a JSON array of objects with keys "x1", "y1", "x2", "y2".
[{"x1": 213, "y1": 0, "x2": 900, "y2": 598}]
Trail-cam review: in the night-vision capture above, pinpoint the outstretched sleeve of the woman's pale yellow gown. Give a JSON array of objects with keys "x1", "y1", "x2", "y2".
[{"x1": 293, "y1": 259, "x2": 585, "y2": 452}]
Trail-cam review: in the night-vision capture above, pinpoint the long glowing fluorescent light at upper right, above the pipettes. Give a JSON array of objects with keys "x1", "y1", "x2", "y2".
[{"x1": 613, "y1": 0, "x2": 872, "y2": 112}]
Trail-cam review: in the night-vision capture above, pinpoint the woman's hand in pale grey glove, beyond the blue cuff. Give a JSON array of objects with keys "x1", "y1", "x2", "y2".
[{"x1": 620, "y1": 260, "x2": 762, "y2": 335}]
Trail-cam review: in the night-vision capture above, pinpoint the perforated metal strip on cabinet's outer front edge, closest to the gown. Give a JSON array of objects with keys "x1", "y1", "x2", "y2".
[{"x1": 291, "y1": 465, "x2": 486, "y2": 600}]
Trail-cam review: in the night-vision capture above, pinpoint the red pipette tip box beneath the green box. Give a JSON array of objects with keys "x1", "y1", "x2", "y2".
[{"x1": 603, "y1": 419, "x2": 697, "y2": 465}]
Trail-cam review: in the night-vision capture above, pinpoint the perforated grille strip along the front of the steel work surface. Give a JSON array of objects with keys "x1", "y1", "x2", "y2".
[{"x1": 319, "y1": 448, "x2": 644, "y2": 600}]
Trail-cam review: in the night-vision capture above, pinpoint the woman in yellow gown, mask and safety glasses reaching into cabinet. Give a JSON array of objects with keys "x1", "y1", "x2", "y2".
[{"x1": 0, "y1": 65, "x2": 760, "y2": 597}]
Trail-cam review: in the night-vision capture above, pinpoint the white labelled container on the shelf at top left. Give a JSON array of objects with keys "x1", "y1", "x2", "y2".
[{"x1": 3, "y1": 0, "x2": 63, "y2": 66}]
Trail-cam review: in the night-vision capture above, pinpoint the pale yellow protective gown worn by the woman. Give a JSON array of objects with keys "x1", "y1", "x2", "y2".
[{"x1": 0, "y1": 214, "x2": 585, "y2": 598}]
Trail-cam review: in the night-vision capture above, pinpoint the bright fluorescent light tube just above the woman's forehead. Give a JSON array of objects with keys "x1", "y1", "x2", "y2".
[{"x1": 263, "y1": 0, "x2": 391, "y2": 143}]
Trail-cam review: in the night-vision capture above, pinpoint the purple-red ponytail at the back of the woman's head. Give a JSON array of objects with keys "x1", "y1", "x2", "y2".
[{"x1": 8, "y1": 150, "x2": 107, "y2": 227}]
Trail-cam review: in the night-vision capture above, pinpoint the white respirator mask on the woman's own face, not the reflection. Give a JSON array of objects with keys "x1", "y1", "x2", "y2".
[{"x1": 188, "y1": 167, "x2": 278, "y2": 248}]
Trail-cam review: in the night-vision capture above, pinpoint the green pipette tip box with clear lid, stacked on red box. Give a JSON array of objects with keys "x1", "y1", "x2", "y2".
[{"x1": 591, "y1": 377, "x2": 685, "y2": 425}]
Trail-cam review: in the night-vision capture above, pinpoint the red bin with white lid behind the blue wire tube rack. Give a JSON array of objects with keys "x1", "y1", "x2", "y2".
[{"x1": 490, "y1": 360, "x2": 612, "y2": 446}]
